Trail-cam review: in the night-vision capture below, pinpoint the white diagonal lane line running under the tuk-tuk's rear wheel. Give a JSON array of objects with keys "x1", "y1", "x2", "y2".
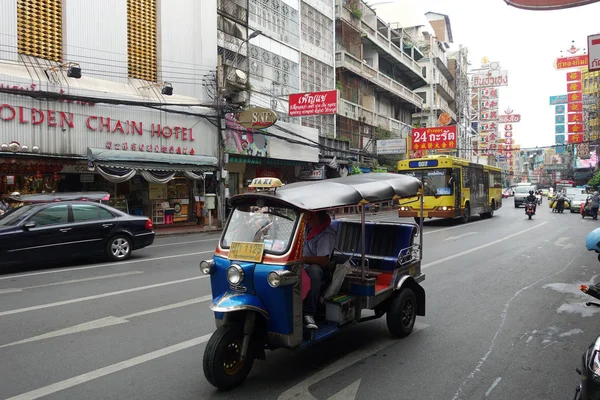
[{"x1": 277, "y1": 322, "x2": 429, "y2": 400}]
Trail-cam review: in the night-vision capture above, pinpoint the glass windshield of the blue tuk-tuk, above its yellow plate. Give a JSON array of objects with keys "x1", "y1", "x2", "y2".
[{"x1": 221, "y1": 206, "x2": 299, "y2": 254}]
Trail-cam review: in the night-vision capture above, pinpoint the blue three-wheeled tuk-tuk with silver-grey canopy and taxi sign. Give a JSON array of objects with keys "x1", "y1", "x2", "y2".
[{"x1": 200, "y1": 173, "x2": 425, "y2": 389}]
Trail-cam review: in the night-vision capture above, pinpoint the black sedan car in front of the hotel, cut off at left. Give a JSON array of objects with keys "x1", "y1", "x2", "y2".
[{"x1": 0, "y1": 201, "x2": 154, "y2": 266}]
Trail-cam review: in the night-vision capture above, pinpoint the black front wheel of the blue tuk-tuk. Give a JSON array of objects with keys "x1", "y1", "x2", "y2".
[{"x1": 203, "y1": 323, "x2": 254, "y2": 390}]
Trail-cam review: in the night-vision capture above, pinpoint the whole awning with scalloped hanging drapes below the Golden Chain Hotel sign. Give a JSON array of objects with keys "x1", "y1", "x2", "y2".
[{"x1": 88, "y1": 148, "x2": 217, "y2": 184}]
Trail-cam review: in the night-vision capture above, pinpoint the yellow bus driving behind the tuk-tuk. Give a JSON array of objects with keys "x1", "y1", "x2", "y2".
[{"x1": 398, "y1": 155, "x2": 502, "y2": 223}]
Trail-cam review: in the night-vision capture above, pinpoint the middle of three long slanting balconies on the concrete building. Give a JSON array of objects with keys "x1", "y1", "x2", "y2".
[{"x1": 335, "y1": 51, "x2": 423, "y2": 107}]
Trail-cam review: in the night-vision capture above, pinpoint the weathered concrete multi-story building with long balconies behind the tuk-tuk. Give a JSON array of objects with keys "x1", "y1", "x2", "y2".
[{"x1": 335, "y1": 0, "x2": 427, "y2": 161}]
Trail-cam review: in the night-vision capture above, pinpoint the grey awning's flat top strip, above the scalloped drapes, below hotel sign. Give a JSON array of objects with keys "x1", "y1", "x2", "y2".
[{"x1": 88, "y1": 148, "x2": 217, "y2": 172}]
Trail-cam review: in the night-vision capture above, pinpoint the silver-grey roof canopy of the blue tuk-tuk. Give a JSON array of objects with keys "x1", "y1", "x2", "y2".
[{"x1": 229, "y1": 173, "x2": 421, "y2": 210}]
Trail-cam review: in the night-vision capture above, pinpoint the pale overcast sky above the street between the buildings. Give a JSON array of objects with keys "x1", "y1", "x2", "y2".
[{"x1": 368, "y1": 0, "x2": 600, "y2": 147}]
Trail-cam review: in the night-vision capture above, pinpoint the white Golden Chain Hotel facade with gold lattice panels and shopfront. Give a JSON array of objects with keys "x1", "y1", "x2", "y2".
[{"x1": 0, "y1": 0, "x2": 218, "y2": 224}]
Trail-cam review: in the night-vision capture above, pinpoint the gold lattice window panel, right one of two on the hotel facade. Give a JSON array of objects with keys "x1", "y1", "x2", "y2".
[{"x1": 127, "y1": 0, "x2": 157, "y2": 82}]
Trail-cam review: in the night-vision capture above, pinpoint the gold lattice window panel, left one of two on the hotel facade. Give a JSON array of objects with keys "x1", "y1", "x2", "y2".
[{"x1": 17, "y1": 0, "x2": 62, "y2": 62}]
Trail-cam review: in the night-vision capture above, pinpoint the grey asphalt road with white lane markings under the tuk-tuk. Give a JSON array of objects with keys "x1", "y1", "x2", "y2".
[{"x1": 0, "y1": 199, "x2": 600, "y2": 400}]
